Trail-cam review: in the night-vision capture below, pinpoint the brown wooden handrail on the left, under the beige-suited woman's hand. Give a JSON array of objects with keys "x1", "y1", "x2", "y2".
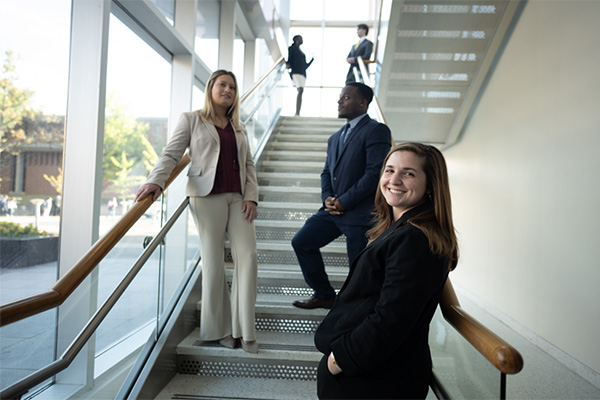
[{"x1": 0, "y1": 153, "x2": 190, "y2": 326}]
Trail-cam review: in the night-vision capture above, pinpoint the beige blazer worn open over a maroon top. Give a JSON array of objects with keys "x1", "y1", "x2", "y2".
[{"x1": 146, "y1": 111, "x2": 258, "y2": 203}]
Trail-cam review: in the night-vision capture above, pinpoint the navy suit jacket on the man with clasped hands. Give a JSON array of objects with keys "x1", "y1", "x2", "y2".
[{"x1": 317, "y1": 115, "x2": 391, "y2": 226}]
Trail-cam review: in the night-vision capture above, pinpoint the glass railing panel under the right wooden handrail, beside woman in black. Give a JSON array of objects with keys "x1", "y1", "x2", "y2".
[{"x1": 429, "y1": 308, "x2": 501, "y2": 399}]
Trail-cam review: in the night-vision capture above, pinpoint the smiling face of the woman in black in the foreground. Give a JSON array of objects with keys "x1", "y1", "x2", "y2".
[{"x1": 379, "y1": 150, "x2": 427, "y2": 221}]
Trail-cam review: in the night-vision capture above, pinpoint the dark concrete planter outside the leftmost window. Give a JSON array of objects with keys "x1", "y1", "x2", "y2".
[{"x1": 0, "y1": 236, "x2": 58, "y2": 268}]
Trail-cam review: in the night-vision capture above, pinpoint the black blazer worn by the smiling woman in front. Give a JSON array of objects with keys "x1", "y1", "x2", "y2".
[{"x1": 315, "y1": 205, "x2": 448, "y2": 398}]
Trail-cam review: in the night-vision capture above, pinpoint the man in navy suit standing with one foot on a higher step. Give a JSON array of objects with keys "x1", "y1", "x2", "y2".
[{"x1": 292, "y1": 82, "x2": 391, "y2": 309}]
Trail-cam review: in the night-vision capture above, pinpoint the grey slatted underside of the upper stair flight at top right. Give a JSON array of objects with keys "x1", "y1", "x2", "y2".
[{"x1": 376, "y1": 0, "x2": 524, "y2": 147}]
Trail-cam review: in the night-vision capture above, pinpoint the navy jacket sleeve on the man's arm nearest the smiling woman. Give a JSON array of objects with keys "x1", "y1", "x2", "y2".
[{"x1": 338, "y1": 123, "x2": 392, "y2": 210}]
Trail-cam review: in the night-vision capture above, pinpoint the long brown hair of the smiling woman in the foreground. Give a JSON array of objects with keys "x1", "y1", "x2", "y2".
[{"x1": 367, "y1": 142, "x2": 458, "y2": 270}]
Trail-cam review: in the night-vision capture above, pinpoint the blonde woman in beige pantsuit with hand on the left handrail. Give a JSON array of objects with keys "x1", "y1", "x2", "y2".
[{"x1": 135, "y1": 70, "x2": 258, "y2": 353}]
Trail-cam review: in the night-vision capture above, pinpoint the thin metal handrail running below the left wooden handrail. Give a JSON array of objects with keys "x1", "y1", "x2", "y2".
[{"x1": 0, "y1": 197, "x2": 189, "y2": 399}]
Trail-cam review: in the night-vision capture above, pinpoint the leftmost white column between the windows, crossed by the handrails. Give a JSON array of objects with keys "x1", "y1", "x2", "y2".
[{"x1": 57, "y1": 0, "x2": 111, "y2": 386}]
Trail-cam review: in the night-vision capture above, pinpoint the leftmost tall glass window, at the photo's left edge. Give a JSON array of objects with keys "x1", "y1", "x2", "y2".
[{"x1": 0, "y1": 0, "x2": 71, "y2": 389}]
